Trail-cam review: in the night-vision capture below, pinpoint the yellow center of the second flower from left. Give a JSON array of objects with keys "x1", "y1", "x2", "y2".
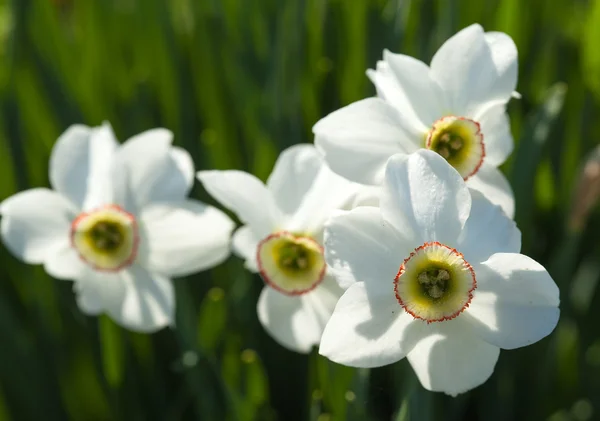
[{"x1": 256, "y1": 231, "x2": 326, "y2": 295}]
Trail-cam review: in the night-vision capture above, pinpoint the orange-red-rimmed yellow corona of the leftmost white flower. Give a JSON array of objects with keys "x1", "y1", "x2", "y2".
[{"x1": 71, "y1": 205, "x2": 139, "y2": 272}]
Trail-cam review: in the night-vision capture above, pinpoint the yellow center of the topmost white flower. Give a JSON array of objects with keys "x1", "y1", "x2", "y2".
[{"x1": 425, "y1": 116, "x2": 485, "y2": 180}]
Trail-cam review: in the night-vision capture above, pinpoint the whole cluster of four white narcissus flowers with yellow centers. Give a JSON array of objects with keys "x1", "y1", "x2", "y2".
[{"x1": 0, "y1": 25, "x2": 559, "y2": 395}]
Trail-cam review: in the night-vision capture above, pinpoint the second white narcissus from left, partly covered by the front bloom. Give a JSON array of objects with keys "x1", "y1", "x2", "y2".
[{"x1": 198, "y1": 144, "x2": 357, "y2": 353}]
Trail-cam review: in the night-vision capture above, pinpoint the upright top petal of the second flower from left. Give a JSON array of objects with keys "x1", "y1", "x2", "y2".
[{"x1": 267, "y1": 144, "x2": 323, "y2": 215}]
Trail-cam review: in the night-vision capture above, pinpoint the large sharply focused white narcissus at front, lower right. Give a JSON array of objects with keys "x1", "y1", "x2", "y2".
[{"x1": 319, "y1": 150, "x2": 559, "y2": 395}]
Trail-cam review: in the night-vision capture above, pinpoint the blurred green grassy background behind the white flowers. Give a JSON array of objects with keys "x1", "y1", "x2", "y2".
[{"x1": 0, "y1": 0, "x2": 600, "y2": 421}]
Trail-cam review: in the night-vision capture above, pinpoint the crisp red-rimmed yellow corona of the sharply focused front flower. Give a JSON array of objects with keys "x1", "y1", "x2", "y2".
[{"x1": 394, "y1": 241, "x2": 477, "y2": 323}]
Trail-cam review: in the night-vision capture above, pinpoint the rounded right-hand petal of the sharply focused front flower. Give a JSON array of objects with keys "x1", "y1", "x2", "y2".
[{"x1": 465, "y1": 253, "x2": 560, "y2": 349}]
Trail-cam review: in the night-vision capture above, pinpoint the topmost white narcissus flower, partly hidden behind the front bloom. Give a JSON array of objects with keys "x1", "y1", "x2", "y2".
[{"x1": 313, "y1": 24, "x2": 518, "y2": 218}]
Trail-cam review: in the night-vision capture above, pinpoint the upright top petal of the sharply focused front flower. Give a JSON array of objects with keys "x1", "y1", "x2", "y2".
[{"x1": 380, "y1": 149, "x2": 471, "y2": 243}]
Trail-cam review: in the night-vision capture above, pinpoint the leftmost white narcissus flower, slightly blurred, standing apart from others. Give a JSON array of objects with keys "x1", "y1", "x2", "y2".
[{"x1": 0, "y1": 124, "x2": 234, "y2": 332}]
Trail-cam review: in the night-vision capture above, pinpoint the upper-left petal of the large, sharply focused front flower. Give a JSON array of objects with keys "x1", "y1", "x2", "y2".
[{"x1": 325, "y1": 207, "x2": 412, "y2": 293}]
